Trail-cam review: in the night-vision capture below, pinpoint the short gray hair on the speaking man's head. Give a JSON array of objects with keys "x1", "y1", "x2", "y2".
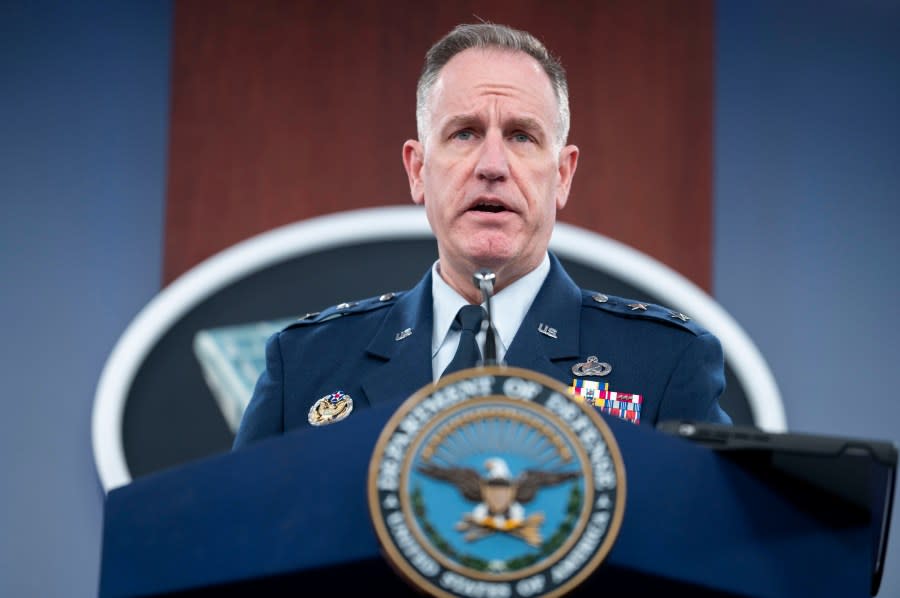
[{"x1": 416, "y1": 23, "x2": 570, "y2": 148}]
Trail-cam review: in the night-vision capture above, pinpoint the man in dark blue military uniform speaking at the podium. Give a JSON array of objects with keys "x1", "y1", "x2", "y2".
[{"x1": 234, "y1": 24, "x2": 730, "y2": 448}]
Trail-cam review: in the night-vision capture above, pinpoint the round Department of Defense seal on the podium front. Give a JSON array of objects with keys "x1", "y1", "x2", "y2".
[{"x1": 368, "y1": 367, "x2": 625, "y2": 598}]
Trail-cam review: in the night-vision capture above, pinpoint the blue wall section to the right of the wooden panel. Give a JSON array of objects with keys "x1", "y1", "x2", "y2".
[{"x1": 713, "y1": 0, "x2": 900, "y2": 597}]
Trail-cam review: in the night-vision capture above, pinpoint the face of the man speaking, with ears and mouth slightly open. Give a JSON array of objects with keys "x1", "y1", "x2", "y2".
[{"x1": 403, "y1": 49, "x2": 578, "y2": 295}]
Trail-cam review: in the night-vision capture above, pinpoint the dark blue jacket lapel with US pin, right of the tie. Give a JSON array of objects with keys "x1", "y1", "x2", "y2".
[{"x1": 506, "y1": 254, "x2": 581, "y2": 384}]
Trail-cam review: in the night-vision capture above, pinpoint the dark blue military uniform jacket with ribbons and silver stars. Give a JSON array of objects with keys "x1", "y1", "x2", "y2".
[{"x1": 234, "y1": 254, "x2": 730, "y2": 448}]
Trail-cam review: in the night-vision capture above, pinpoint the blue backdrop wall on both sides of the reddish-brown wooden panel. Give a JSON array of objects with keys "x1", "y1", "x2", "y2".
[{"x1": 0, "y1": 0, "x2": 900, "y2": 597}]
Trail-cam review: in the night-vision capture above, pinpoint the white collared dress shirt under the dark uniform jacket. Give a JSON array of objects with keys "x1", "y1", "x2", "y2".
[{"x1": 431, "y1": 254, "x2": 550, "y2": 381}]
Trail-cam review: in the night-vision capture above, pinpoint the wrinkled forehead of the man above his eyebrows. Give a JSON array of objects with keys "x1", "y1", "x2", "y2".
[{"x1": 429, "y1": 48, "x2": 557, "y2": 127}]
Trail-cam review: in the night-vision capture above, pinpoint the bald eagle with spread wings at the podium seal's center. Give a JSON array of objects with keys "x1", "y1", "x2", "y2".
[{"x1": 418, "y1": 457, "x2": 581, "y2": 546}]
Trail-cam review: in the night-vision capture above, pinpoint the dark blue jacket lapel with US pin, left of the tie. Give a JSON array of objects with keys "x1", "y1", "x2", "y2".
[{"x1": 361, "y1": 269, "x2": 434, "y2": 405}]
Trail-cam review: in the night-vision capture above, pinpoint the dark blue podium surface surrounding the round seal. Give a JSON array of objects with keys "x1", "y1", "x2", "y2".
[{"x1": 100, "y1": 404, "x2": 893, "y2": 598}]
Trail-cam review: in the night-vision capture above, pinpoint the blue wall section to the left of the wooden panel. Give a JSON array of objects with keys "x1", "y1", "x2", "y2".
[{"x1": 0, "y1": 1, "x2": 172, "y2": 598}]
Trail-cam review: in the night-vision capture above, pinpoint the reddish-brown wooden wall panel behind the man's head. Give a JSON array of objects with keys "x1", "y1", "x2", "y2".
[{"x1": 164, "y1": 0, "x2": 713, "y2": 289}]
